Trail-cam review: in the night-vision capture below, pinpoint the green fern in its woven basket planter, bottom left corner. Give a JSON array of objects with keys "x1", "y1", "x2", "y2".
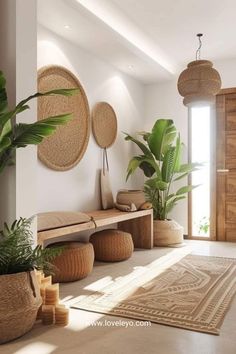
[{"x1": 0, "y1": 218, "x2": 62, "y2": 343}]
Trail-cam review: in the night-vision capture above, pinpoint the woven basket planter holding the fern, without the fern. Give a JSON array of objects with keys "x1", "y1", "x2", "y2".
[{"x1": 0, "y1": 271, "x2": 42, "y2": 343}]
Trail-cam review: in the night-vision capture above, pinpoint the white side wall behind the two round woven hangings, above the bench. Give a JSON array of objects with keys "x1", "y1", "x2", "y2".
[{"x1": 37, "y1": 26, "x2": 144, "y2": 212}]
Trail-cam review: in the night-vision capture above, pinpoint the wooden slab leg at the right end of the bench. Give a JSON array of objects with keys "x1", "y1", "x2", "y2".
[{"x1": 118, "y1": 215, "x2": 153, "y2": 249}]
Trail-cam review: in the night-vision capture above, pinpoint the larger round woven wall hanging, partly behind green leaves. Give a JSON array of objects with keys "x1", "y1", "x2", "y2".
[{"x1": 38, "y1": 65, "x2": 90, "y2": 171}]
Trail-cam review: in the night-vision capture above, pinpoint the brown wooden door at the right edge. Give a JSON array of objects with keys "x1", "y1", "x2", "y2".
[{"x1": 216, "y1": 88, "x2": 236, "y2": 242}]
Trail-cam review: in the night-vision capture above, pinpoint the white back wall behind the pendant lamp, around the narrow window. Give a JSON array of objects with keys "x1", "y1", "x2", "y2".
[{"x1": 145, "y1": 59, "x2": 236, "y2": 233}]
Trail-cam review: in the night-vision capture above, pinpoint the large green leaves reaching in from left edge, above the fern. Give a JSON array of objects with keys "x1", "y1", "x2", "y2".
[{"x1": 0, "y1": 71, "x2": 78, "y2": 174}]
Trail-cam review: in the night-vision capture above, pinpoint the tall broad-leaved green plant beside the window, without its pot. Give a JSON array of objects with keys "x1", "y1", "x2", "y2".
[{"x1": 125, "y1": 119, "x2": 201, "y2": 220}]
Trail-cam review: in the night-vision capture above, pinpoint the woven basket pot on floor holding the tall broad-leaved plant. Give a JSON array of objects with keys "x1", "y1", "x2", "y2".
[{"x1": 153, "y1": 220, "x2": 184, "y2": 246}]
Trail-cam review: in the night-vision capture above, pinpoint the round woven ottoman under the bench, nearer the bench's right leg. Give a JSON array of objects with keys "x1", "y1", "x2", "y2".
[{"x1": 89, "y1": 229, "x2": 134, "y2": 262}]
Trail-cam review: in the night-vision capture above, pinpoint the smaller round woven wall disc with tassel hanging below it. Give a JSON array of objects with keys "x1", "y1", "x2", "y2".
[{"x1": 92, "y1": 102, "x2": 117, "y2": 149}]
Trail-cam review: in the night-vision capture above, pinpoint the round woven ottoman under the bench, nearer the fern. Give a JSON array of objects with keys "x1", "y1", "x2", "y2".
[{"x1": 48, "y1": 241, "x2": 94, "y2": 283}]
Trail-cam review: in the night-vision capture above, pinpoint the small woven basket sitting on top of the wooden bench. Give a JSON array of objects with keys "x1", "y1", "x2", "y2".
[{"x1": 116, "y1": 189, "x2": 145, "y2": 210}]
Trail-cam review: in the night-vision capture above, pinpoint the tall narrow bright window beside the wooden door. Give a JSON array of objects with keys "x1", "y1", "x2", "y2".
[{"x1": 189, "y1": 106, "x2": 211, "y2": 238}]
